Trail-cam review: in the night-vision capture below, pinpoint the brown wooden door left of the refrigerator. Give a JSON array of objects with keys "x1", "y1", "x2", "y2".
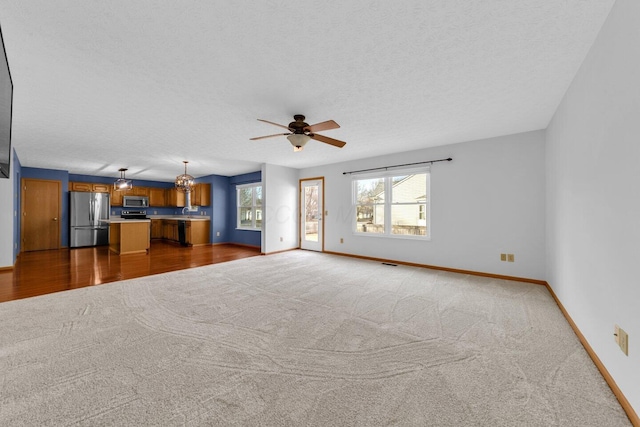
[{"x1": 21, "y1": 178, "x2": 61, "y2": 251}]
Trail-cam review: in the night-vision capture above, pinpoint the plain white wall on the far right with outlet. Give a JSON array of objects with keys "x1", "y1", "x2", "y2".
[{"x1": 546, "y1": 0, "x2": 640, "y2": 413}]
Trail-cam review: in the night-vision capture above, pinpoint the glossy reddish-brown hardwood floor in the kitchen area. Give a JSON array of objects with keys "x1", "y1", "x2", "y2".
[{"x1": 0, "y1": 241, "x2": 260, "y2": 302}]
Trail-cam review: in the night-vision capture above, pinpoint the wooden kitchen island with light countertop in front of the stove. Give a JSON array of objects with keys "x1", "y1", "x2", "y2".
[{"x1": 104, "y1": 218, "x2": 151, "y2": 255}]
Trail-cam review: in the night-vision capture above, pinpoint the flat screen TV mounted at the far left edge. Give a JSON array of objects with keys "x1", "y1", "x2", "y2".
[{"x1": 0, "y1": 24, "x2": 13, "y2": 178}]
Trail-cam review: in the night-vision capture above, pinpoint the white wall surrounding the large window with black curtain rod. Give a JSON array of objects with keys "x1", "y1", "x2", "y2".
[{"x1": 300, "y1": 131, "x2": 545, "y2": 280}]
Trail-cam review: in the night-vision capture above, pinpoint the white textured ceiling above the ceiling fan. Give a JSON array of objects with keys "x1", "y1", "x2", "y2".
[{"x1": 0, "y1": 0, "x2": 614, "y2": 181}]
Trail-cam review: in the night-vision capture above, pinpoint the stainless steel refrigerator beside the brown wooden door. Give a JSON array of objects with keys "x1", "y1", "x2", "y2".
[{"x1": 69, "y1": 191, "x2": 110, "y2": 248}]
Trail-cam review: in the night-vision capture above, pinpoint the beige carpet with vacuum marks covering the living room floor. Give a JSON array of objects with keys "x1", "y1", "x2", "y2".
[{"x1": 0, "y1": 251, "x2": 630, "y2": 426}]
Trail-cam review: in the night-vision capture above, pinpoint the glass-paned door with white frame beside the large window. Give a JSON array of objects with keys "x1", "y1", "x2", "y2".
[{"x1": 300, "y1": 178, "x2": 324, "y2": 252}]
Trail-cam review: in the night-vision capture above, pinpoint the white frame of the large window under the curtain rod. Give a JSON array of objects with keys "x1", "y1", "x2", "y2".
[{"x1": 351, "y1": 166, "x2": 431, "y2": 240}]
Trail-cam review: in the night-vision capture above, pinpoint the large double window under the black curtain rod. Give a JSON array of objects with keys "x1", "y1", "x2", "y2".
[{"x1": 353, "y1": 169, "x2": 430, "y2": 239}]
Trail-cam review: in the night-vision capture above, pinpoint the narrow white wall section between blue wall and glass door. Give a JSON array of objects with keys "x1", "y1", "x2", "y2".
[{"x1": 262, "y1": 164, "x2": 298, "y2": 254}]
